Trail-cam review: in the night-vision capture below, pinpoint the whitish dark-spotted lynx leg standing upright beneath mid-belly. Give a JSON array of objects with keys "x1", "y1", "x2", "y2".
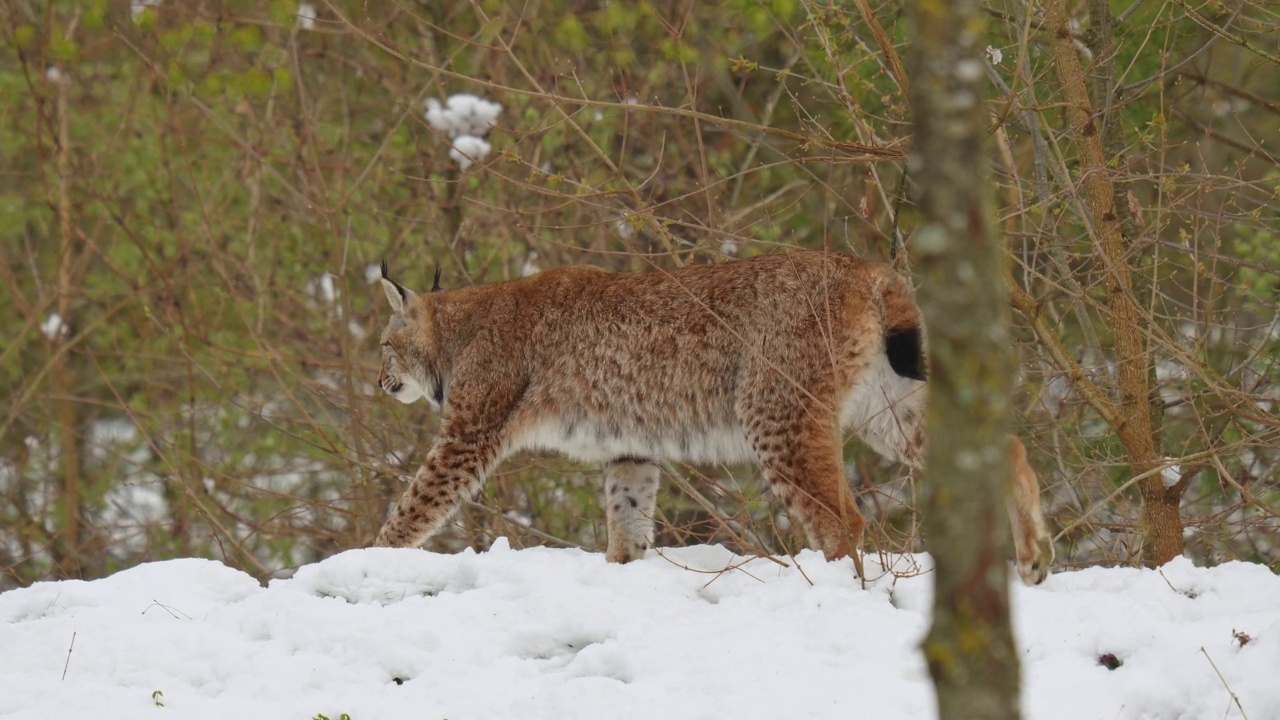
[{"x1": 604, "y1": 457, "x2": 658, "y2": 562}]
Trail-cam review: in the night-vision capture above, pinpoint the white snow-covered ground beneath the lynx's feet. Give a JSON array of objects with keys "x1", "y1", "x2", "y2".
[{"x1": 0, "y1": 541, "x2": 1280, "y2": 720}]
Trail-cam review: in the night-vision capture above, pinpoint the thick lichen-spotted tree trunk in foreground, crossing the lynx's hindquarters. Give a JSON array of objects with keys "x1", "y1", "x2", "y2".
[{"x1": 908, "y1": 0, "x2": 1019, "y2": 720}]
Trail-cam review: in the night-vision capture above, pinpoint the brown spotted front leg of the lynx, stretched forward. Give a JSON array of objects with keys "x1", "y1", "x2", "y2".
[{"x1": 374, "y1": 439, "x2": 498, "y2": 547}]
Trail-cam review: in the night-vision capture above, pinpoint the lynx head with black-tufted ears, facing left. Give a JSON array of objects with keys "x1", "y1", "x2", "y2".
[{"x1": 378, "y1": 260, "x2": 444, "y2": 407}]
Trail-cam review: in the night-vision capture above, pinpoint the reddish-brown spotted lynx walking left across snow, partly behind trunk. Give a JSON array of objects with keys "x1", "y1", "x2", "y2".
[{"x1": 375, "y1": 251, "x2": 1052, "y2": 583}]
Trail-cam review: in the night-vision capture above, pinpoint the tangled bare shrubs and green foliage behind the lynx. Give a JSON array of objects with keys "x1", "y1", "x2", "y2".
[{"x1": 0, "y1": 0, "x2": 1280, "y2": 589}]
